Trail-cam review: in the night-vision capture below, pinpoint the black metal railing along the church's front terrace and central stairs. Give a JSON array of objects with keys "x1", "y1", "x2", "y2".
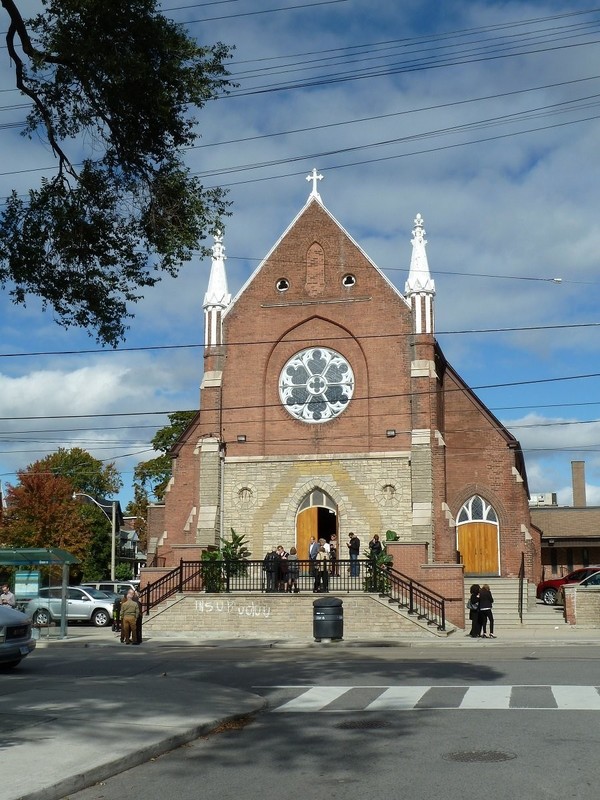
[{"x1": 140, "y1": 559, "x2": 446, "y2": 630}]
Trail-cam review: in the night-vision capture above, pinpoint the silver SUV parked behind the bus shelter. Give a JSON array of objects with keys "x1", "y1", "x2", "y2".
[{"x1": 25, "y1": 586, "x2": 113, "y2": 628}]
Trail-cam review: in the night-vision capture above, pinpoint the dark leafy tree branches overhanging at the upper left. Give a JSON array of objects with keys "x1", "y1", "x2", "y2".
[{"x1": 0, "y1": 0, "x2": 231, "y2": 346}]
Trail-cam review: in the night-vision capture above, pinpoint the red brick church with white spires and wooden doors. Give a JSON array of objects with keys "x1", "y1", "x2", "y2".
[{"x1": 149, "y1": 170, "x2": 540, "y2": 582}]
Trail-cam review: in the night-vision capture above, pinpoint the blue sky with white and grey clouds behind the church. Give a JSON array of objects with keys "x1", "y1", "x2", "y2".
[{"x1": 0, "y1": 0, "x2": 600, "y2": 506}]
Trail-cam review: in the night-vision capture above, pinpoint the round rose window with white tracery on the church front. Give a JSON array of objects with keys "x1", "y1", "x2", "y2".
[{"x1": 279, "y1": 347, "x2": 354, "y2": 422}]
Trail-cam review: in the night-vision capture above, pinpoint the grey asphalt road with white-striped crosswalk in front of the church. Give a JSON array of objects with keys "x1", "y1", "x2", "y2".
[{"x1": 21, "y1": 642, "x2": 600, "y2": 800}]
